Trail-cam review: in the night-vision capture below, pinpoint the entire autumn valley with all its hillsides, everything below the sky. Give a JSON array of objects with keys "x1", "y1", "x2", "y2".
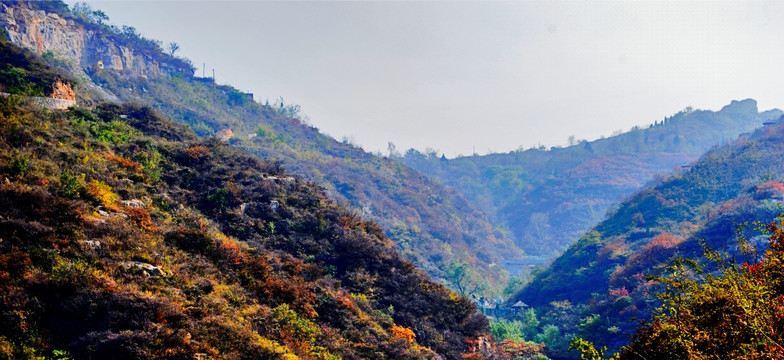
[{"x1": 0, "y1": 0, "x2": 784, "y2": 360}]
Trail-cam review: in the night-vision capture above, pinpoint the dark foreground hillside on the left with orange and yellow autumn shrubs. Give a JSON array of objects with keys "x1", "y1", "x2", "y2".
[{"x1": 0, "y1": 39, "x2": 496, "y2": 359}]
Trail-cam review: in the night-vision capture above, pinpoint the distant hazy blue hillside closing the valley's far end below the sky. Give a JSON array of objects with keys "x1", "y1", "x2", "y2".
[{"x1": 396, "y1": 99, "x2": 782, "y2": 257}]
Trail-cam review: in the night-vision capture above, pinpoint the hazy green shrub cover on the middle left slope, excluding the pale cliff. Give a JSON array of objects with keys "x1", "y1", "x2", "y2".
[{"x1": 10, "y1": 0, "x2": 522, "y2": 292}]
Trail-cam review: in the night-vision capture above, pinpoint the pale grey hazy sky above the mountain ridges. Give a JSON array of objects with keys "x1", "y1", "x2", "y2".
[{"x1": 69, "y1": 1, "x2": 784, "y2": 157}]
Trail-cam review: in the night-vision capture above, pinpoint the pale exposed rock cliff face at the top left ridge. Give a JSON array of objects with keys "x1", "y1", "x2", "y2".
[{"x1": 0, "y1": 4, "x2": 193, "y2": 76}]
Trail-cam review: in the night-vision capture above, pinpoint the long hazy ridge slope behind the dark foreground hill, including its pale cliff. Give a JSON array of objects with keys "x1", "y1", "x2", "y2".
[{"x1": 0, "y1": 2, "x2": 522, "y2": 285}]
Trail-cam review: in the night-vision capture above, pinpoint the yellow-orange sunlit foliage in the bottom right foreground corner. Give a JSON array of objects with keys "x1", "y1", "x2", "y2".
[{"x1": 620, "y1": 221, "x2": 784, "y2": 359}]
